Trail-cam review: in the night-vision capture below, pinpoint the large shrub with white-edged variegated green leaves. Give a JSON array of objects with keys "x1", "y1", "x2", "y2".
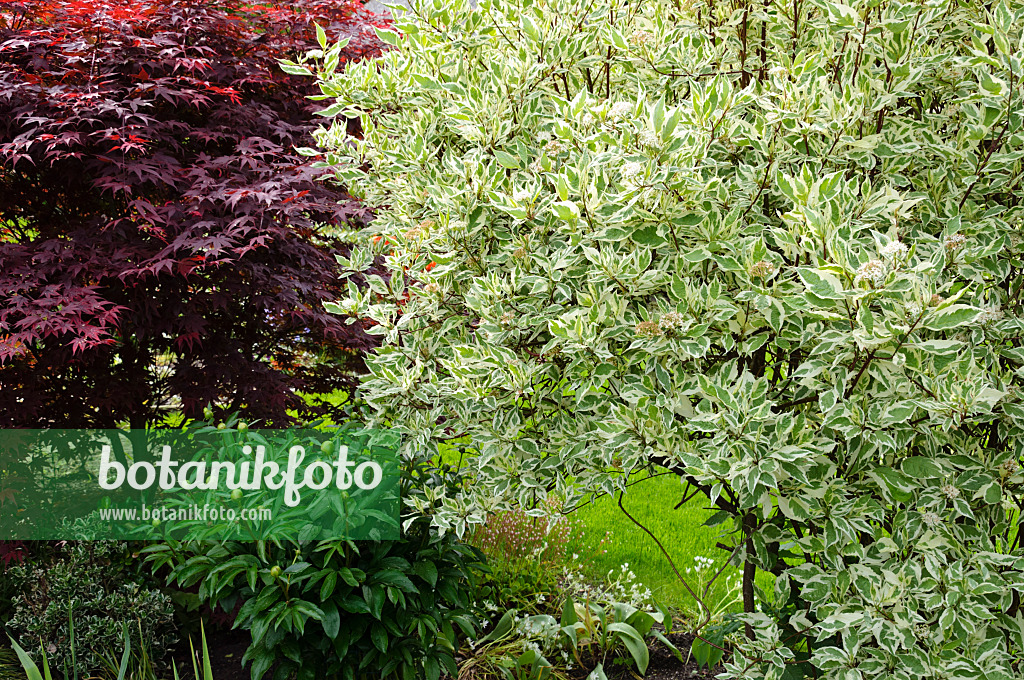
[{"x1": 301, "y1": 0, "x2": 1024, "y2": 680}]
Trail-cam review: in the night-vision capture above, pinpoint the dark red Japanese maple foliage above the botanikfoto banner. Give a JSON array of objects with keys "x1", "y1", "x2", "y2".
[{"x1": 0, "y1": 0, "x2": 381, "y2": 427}]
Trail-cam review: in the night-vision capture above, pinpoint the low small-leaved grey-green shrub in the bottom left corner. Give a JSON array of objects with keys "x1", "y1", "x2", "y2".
[{"x1": 7, "y1": 541, "x2": 177, "y2": 677}]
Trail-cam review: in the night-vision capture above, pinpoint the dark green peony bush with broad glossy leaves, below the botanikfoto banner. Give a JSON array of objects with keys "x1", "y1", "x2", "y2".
[{"x1": 146, "y1": 458, "x2": 483, "y2": 680}]
